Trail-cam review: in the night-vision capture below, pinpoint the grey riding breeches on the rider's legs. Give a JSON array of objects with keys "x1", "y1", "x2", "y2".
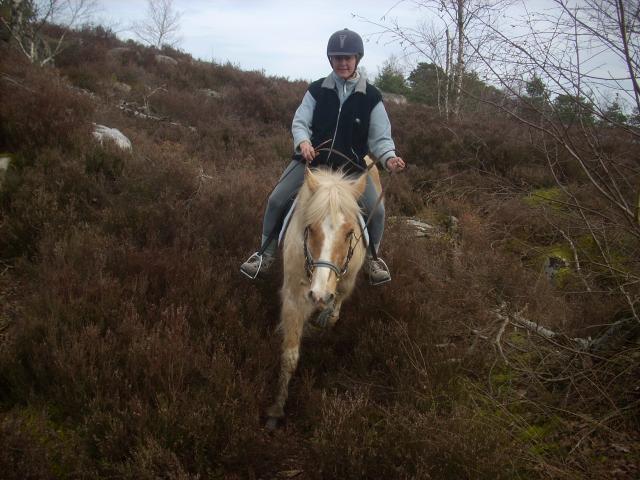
[{"x1": 262, "y1": 160, "x2": 384, "y2": 255}]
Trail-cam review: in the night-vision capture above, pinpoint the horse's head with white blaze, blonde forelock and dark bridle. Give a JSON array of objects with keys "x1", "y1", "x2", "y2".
[{"x1": 304, "y1": 169, "x2": 367, "y2": 308}]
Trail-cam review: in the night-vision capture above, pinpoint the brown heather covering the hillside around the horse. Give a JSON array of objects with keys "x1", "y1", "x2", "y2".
[{"x1": 0, "y1": 28, "x2": 640, "y2": 479}]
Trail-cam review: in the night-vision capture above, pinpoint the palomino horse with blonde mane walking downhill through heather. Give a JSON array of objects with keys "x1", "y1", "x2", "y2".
[{"x1": 267, "y1": 162, "x2": 381, "y2": 429}]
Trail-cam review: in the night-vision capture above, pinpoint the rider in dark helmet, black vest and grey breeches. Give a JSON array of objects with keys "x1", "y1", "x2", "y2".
[{"x1": 240, "y1": 28, "x2": 405, "y2": 285}]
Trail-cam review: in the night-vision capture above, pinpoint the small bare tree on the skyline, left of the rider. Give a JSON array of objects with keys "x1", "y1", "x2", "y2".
[{"x1": 132, "y1": 0, "x2": 182, "y2": 48}]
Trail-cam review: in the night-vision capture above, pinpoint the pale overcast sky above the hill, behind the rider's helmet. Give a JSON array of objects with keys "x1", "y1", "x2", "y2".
[{"x1": 97, "y1": 0, "x2": 424, "y2": 80}]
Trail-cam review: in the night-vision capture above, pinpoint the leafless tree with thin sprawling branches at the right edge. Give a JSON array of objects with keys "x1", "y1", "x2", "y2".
[{"x1": 469, "y1": 0, "x2": 640, "y2": 322}]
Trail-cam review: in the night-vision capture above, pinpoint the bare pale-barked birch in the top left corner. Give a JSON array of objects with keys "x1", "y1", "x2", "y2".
[{"x1": 0, "y1": 0, "x2": 96, "y2": 65}]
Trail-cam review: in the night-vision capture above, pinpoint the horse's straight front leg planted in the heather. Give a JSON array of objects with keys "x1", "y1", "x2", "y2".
[{"x1": 267, "y1": 292, "x2": 312, "y2": 429}]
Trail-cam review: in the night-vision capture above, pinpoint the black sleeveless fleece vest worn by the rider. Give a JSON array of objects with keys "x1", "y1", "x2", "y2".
[{"x1": 294, "y1": 78, "x2": 382, "y2": 174}]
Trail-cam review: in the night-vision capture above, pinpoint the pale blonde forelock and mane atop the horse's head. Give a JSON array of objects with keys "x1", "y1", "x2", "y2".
[{"x1": 304, "y1": 169, "x2": 360, "y2": 225}]
